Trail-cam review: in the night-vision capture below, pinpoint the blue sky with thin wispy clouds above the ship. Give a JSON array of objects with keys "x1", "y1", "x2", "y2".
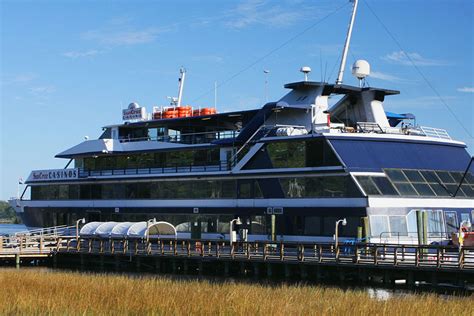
[{"x1": 0, "y1": 0, "x2": 474, "y2": 199}]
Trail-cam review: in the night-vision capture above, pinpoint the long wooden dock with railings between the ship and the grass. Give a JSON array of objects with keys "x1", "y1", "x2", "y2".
[{"x1": 0, "y1": 236, "x2": 474, "y2": 288}]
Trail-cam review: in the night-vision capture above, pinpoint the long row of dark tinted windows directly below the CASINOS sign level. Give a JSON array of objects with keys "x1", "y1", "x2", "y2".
[{"x1": 31, "y1": 176, "x2": 361, "y2": 200}]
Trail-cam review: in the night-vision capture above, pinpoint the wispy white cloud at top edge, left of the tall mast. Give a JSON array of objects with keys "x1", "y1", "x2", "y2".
[{"x1": 226, "y1": 0, "x2": 306, "y2": 29}]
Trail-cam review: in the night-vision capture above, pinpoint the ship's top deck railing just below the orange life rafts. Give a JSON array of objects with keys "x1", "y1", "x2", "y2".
[{"x1": 119, "y1": 130, "x2": 240, "y2": 144}]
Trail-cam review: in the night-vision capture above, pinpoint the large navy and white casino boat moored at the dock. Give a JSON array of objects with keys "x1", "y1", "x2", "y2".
[{"x1": 11, "y1": 1, "x2": 474, "y2": 244}]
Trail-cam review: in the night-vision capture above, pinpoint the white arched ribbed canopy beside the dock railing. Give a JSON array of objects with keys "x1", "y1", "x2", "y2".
[{"x1": 79, "y1": 221, "x2": 176, "y2": 239}]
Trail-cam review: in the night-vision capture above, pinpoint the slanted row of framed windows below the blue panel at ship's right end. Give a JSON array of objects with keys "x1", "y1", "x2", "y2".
[{"x1": 356, "y1": 169, "x2": 474, "y2": 198}]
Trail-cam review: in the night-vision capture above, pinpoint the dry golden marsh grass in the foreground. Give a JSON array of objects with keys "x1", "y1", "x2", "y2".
[{"x1": 0, "y1": 269, "x2": 474, "y2": 316}]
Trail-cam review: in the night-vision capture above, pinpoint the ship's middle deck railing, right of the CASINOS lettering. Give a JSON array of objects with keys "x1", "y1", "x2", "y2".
[{"x1": 79, "y1": 161, "x2": 230, "y2": 178}]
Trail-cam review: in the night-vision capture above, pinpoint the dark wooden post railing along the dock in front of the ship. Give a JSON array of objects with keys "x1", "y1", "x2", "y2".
[{"x1": 58, "y1": 238, "x2": 474, "y2": 270}]
